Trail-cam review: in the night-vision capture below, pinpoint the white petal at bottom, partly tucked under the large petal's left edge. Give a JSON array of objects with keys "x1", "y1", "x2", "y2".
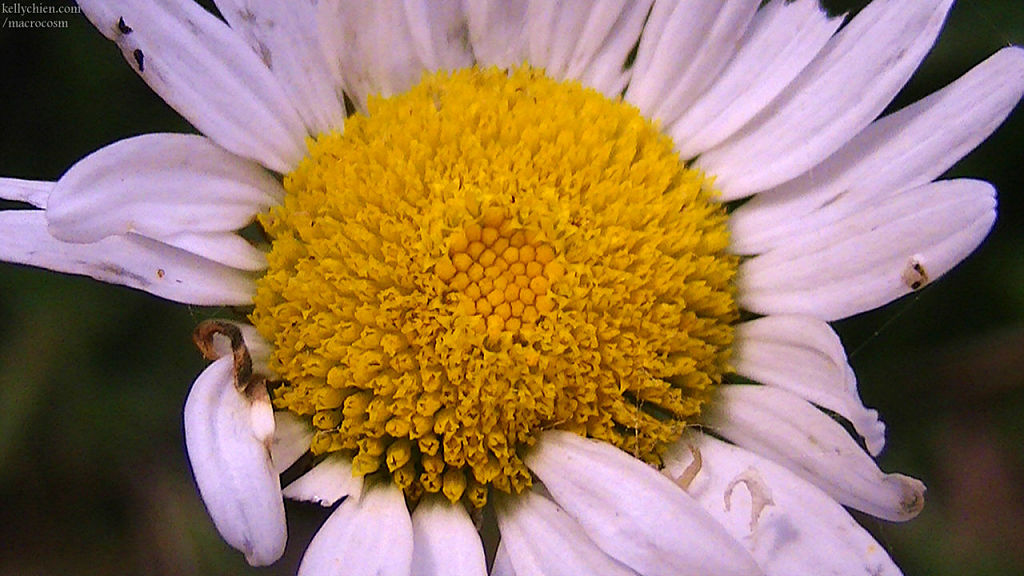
[{"x1": 498, "y1": 483, "x2": 636, "y2": 576}]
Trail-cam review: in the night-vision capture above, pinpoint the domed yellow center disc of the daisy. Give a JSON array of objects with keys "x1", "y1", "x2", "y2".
[{"x1": 251, "y1": 68, "x2": 737, "y2": 506}]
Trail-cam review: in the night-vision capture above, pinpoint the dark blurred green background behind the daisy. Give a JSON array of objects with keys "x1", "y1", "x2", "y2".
[{"x1": 0, "y1": 0, "x2": 1024, "y2": 576}]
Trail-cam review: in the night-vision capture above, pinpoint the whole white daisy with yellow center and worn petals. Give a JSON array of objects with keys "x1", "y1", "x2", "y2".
[{"x1": 0, "y1": 0, "x2": 1024, "y2": 576}]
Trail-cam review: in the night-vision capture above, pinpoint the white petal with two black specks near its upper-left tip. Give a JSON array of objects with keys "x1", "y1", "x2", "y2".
[{"x1": 79, "y1": 0, "x2": 306, "y2": 173}]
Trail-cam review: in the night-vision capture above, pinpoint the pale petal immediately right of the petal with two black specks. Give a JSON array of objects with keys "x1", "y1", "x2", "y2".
[{"x1": 216, "y1": 0, "x2": 345, "y2": 135}]
